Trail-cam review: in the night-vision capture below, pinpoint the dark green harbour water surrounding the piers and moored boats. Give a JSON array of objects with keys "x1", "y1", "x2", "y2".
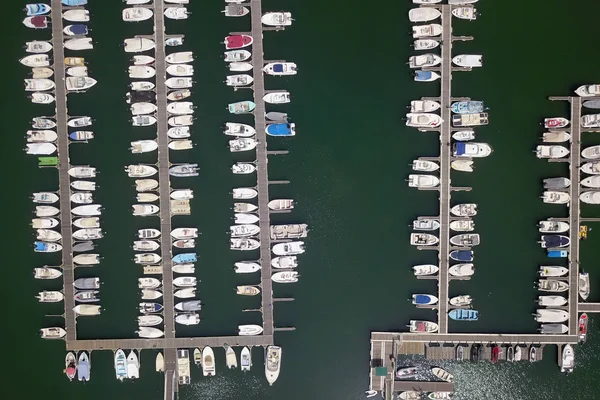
[{"x1": 0, "y1": 0, "x2": 600, "y2": 400}]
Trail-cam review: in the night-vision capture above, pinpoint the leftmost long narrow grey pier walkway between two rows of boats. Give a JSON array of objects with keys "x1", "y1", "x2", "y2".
[{"x1": 51, "y1": 0, "x2": 77, "y2": 341}]
